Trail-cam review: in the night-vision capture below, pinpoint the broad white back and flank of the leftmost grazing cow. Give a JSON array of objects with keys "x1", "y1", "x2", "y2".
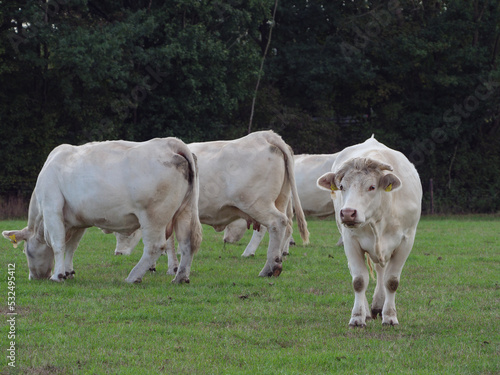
[{"x1": 35, "y1": 138, "x2": 189, "y2": 230}]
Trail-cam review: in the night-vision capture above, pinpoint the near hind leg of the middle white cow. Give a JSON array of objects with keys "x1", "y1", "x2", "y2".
[{"x1": 259, "y1": 214, "x2": 287, "y2": 277}]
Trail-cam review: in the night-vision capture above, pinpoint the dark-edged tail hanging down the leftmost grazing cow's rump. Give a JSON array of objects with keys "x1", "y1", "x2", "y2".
[{"x1": 173, "y1": 140, "x2": 202, "y2": 253}]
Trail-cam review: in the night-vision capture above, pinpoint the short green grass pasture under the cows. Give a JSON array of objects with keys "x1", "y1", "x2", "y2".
[{"x1": 0, "y1": 216, "x2": 500, "y2": 374}]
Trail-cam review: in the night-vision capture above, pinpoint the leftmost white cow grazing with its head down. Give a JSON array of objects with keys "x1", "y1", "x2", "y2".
[{"x1": 2, "y1": 138, "x2": 202, "y2": 283}]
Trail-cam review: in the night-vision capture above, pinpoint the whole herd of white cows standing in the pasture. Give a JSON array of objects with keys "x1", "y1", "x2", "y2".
[{"x1": 2, "y1": 131, "x2": 422, "y2": 327}]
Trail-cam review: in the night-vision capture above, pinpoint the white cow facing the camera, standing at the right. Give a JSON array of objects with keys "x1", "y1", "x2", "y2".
[{"x1": 317, "y1": 136, "x2": 422, "y2": 327}]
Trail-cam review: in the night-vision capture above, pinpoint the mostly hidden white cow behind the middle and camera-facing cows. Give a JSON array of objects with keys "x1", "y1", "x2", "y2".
[{"x1": 228, "y1": 153, "x2": 338, "y2": 257}]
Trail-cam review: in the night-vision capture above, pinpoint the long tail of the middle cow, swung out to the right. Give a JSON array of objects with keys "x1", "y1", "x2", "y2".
[{"x1": 269, "y1": 134, "x2": 309, "y2": 245}]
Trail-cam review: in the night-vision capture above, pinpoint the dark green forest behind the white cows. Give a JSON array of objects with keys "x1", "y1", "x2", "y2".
[{"x1": 0, "y1": 0, "x2": 500, "y2": 213}]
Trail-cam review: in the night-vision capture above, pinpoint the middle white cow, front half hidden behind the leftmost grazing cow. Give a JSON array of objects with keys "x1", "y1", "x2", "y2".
[{"x1": 115, "y1": 131, "x2": 309, "y2": 276}]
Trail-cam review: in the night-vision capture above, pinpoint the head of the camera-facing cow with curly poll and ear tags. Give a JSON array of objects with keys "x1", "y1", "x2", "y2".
[{"x1": 317, "y1": 158, "x2": 401, "y2": 228}]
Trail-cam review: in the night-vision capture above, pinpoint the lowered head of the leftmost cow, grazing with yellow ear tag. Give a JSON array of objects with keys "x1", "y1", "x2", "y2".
[{"x1": 2, "y1": 227, "x2": 54, "y2": 280}]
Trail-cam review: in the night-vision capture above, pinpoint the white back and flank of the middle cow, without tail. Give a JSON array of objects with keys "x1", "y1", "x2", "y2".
[{"x1": 188, "y1": 132, "x2": 285, "y2": 223}]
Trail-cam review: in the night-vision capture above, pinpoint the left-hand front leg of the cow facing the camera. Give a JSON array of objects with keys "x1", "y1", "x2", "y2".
[{"x1": 344, "y1": 237, "x2": 371, "y2": 327}]
